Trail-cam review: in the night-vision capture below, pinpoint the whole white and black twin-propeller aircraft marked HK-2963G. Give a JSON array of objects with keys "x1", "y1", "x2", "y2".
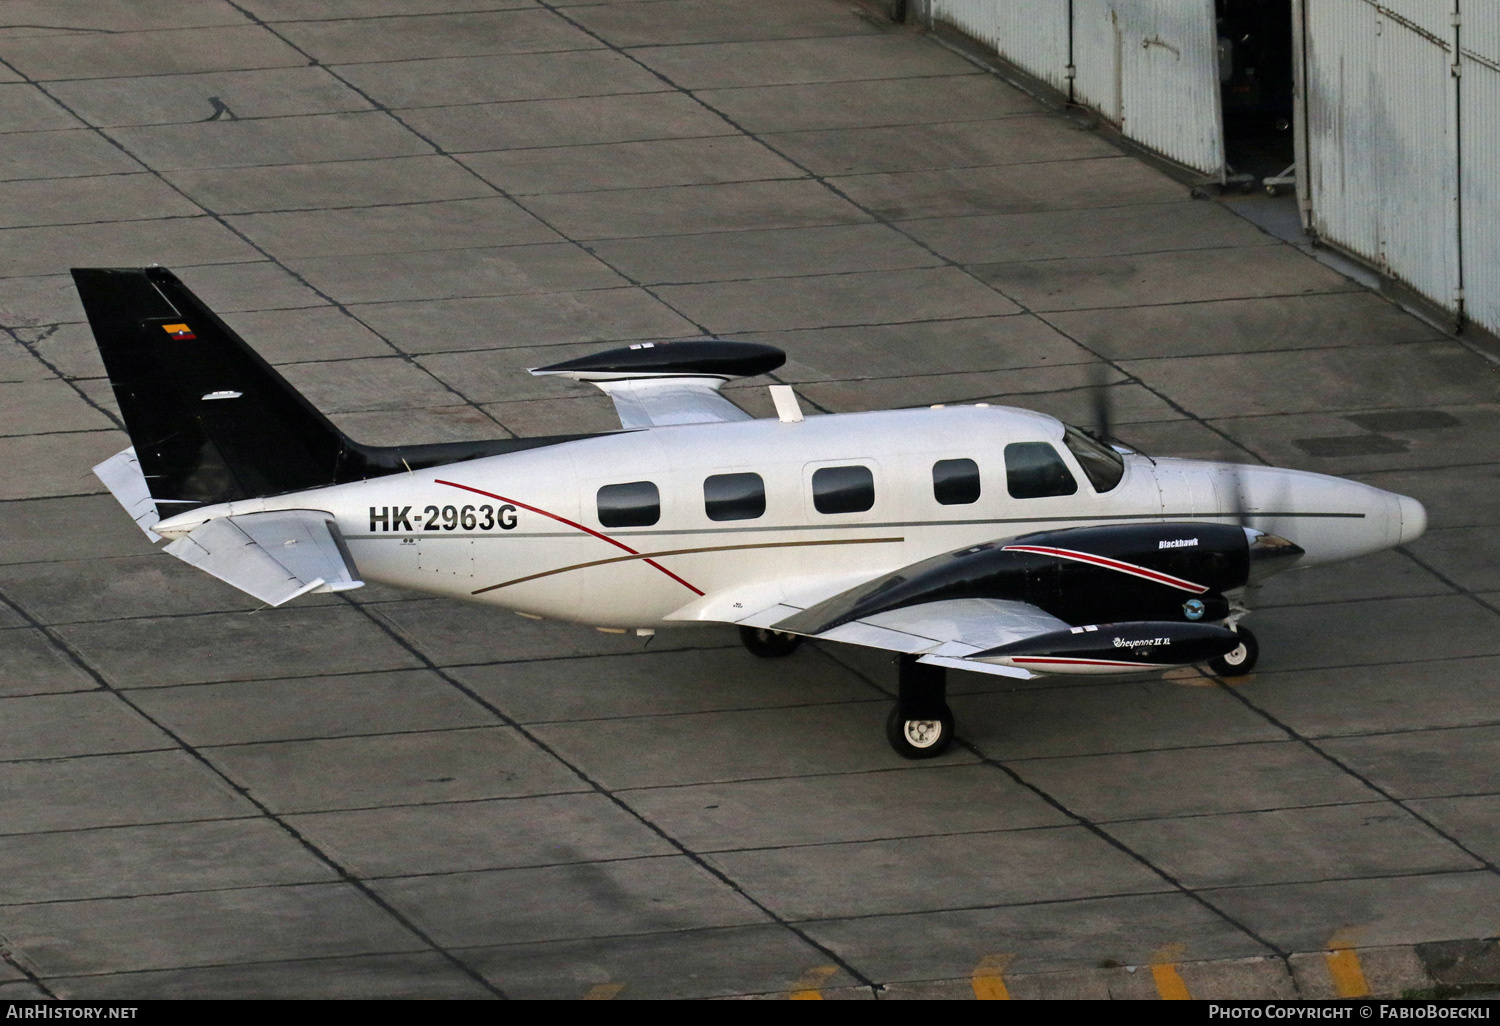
[{"x1": 74, "y1": 267, "x2": 1427, "y2": 758}]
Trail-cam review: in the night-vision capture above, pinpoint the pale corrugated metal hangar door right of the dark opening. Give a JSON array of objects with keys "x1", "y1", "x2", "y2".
[{"x1": 1301, "y1": 0, "x2": 1500, "y2": 332}]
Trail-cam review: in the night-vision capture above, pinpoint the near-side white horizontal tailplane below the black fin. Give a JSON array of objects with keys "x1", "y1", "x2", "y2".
[{"x1": 167, "y1": 510, "x2": 365, "y2": 606}]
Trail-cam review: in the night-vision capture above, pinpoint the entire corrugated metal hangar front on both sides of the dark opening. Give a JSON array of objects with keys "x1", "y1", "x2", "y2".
[{"x1": 926, "y1": 0, "x2": 1500, "y2": 333}]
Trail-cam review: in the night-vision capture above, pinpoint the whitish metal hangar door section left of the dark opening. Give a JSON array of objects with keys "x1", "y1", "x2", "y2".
[{"x1": 930, "y1": 0, "x2": 1224, "y2": 180}]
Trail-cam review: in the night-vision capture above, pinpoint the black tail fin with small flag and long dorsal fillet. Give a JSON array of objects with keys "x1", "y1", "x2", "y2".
[{"x1": 74, "y1": 267, "x2": 597, "y2": 516}]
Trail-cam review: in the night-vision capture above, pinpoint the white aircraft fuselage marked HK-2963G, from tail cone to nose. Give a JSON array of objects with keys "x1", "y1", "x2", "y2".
[{"x1": 156, "y1": 407, "x2": 1425, "y2": 629}]
